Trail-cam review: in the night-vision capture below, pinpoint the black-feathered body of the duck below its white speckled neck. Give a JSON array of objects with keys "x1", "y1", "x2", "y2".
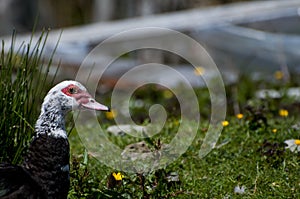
[{"x1": 0, "y1": 134, "x2": 70, "y2": 199}]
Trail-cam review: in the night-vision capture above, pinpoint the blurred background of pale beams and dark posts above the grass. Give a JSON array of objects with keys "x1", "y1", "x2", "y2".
[{"x1": 0, "y1": 0, "x2": 300, "y2": 87}]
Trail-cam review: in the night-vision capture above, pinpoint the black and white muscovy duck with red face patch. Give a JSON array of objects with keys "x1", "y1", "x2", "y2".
[{"x1": 0, "y1": 81, "x2": 109, "y2": 199}]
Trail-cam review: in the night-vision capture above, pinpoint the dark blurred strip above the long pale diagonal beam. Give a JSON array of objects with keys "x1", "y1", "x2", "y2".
[{"x1": 0, "y1": 0, "x2": 249, "y2": 35}]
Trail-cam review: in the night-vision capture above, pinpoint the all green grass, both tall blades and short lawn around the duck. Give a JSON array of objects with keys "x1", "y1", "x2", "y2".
[{"x1": 0, "y1": 33, "x2": 300, "y2": 198}]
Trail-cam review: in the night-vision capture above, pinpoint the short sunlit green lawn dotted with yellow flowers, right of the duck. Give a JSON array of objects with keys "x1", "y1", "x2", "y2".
[{"x1": 69, "y1": 78, "x2": 300, "y2": 198}]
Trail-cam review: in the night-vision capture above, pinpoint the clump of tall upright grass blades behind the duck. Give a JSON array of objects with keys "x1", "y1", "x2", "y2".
[{"x1": 0, "y1": 29, "x2": 58, "y2": 163}]
